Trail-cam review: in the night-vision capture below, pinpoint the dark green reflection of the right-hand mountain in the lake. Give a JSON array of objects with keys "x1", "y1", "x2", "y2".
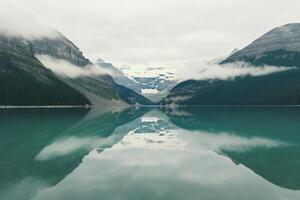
[{"x1": 166, "y1": 107, "x2": 300, "y2": 190}]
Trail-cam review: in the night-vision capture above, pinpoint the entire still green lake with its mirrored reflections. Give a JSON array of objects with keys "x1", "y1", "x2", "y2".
[{"x1": 0, "y1": 107, "x2": 300, "y2": 200}]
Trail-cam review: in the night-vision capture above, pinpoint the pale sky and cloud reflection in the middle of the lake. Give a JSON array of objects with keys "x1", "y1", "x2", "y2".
[{"x1": 30, "y1": 112, "x2": 300, "y2": 200}]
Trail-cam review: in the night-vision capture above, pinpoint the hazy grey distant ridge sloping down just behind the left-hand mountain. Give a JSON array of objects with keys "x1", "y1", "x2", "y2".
[{"x1": 96, "y1": 59, "x2": 141, "y2": 93}]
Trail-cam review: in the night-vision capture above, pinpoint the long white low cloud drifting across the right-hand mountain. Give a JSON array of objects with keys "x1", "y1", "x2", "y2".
[{"x1": 175, "y1": 62, "x2": 293, "y2": 81}]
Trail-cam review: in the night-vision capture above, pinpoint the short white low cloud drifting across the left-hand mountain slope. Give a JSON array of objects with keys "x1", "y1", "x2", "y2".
[{"x1": 36, "y1": 55, "x2": 107, "y2": 78}]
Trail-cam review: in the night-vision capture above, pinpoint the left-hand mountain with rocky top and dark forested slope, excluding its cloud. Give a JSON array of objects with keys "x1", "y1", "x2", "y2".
[{"x1": 0, "y1": 28, "x2": 152, "y2": 106}]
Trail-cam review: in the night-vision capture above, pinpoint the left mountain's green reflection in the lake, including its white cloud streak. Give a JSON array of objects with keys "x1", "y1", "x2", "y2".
[{"x1": 0, "y1": 108, "x2": 146, "y2": 199}]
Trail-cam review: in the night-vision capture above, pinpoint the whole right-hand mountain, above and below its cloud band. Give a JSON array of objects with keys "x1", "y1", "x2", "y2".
[{"x1": 161, "y1": 24, "x2": 300, "y2": 105}]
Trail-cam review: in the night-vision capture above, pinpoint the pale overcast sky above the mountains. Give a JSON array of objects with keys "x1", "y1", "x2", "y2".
[{"x1": 0, "y1": 0, "x2": 300, "y2": 67}]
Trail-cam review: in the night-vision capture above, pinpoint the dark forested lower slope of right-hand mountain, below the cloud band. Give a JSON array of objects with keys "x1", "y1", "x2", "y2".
[{"x1": 162, "y1": 69, "x2": 300, "y2": 105}]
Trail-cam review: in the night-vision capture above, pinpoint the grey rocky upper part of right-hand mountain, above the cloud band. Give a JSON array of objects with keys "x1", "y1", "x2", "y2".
[{"x1": 221, "y1": 23, "x2": 300, "y2": 67}]
